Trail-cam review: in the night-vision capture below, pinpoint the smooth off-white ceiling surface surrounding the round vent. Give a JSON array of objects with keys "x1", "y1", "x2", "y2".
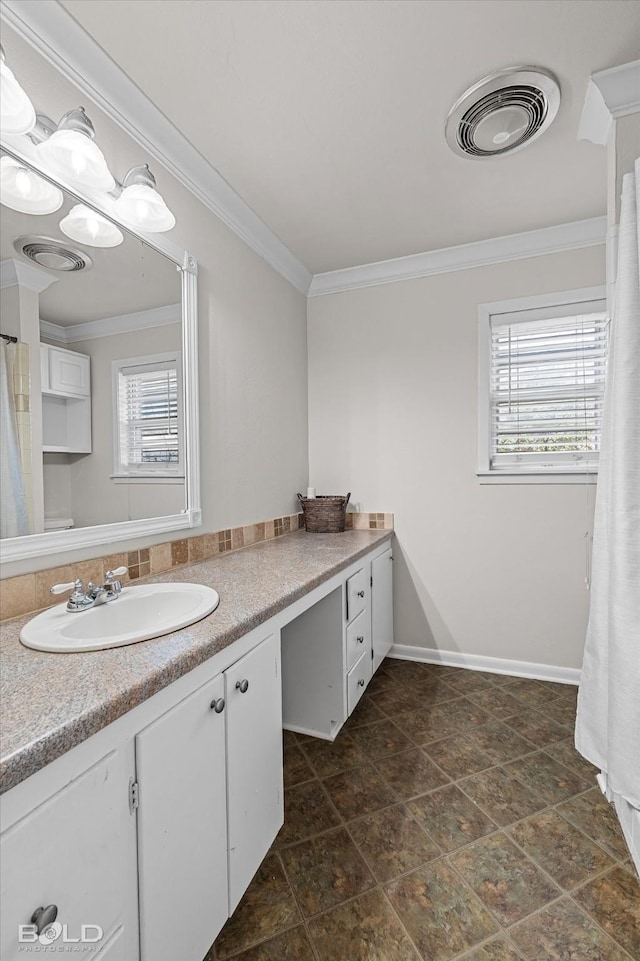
[{"x1": 38, "y1": 0, "x2": 640, "y2": 273}]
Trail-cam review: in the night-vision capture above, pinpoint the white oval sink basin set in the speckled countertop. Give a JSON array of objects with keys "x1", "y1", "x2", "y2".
[{"x1": 20, "y1": 584, "x2": 220, "y2": 653}]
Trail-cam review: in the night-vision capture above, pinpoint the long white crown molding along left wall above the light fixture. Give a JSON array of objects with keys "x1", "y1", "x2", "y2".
[{"x1": 0, "y1": 0, "x2": 311, "y2": 294}]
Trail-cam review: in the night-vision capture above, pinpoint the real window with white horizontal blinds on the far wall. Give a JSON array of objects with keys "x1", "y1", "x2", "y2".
[{"x1": 478, "y1": 288, "x2": 608, "y2": 483}]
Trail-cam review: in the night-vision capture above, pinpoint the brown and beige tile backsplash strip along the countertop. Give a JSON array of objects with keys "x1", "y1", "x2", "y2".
[{"x1": 0, "y1": 512, "x2": 393, "y2": 620}]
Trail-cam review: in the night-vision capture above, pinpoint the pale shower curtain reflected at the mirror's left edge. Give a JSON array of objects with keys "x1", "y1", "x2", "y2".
[{"x1": 0, "y1": 341, "x2": 29, "y2": 537}]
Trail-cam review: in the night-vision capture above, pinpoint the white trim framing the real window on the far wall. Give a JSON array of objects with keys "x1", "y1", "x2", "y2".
[{"x1": 476, "y1": 285, "x2": 606, "y2": 484}]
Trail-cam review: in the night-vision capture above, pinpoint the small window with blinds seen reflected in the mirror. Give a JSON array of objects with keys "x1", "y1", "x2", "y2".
[{"x1": 112, "y1": 352, "x2": 184, "y2": 480}]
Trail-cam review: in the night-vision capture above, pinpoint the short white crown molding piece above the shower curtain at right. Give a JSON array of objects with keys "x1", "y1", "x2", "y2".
[{"x1": 578, "y1": 60, "x2": 640, "y2": 145}]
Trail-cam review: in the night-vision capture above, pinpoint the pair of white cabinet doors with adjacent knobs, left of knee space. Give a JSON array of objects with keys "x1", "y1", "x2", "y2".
[{"x1": 135, "y1": 634, "x2": 283, "y2": 961}]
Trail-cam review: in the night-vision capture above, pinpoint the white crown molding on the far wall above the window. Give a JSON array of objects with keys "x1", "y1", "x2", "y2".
[{"x1": 308, "y1": 217, "x2": 607, "y2": 297}]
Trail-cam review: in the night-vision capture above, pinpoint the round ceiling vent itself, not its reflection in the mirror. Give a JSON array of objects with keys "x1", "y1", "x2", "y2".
[{"x1": 445, "y1": 67, "x2": 560, "y2": 158}]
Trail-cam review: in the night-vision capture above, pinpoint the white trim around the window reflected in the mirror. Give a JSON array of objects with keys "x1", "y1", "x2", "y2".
[{"x1": 109, "y1": 350, "x2": 185, "y2": 484}]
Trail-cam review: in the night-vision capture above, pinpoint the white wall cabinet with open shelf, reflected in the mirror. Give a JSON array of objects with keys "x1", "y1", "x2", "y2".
[{"x1": 40, "y1": 344, "x2": 91, "y2": 454}]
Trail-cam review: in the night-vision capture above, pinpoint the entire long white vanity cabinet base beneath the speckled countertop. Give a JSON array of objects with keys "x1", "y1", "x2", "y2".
[{"x1": 0, "y1": 541, "x2": 392, "y2": 961}]
